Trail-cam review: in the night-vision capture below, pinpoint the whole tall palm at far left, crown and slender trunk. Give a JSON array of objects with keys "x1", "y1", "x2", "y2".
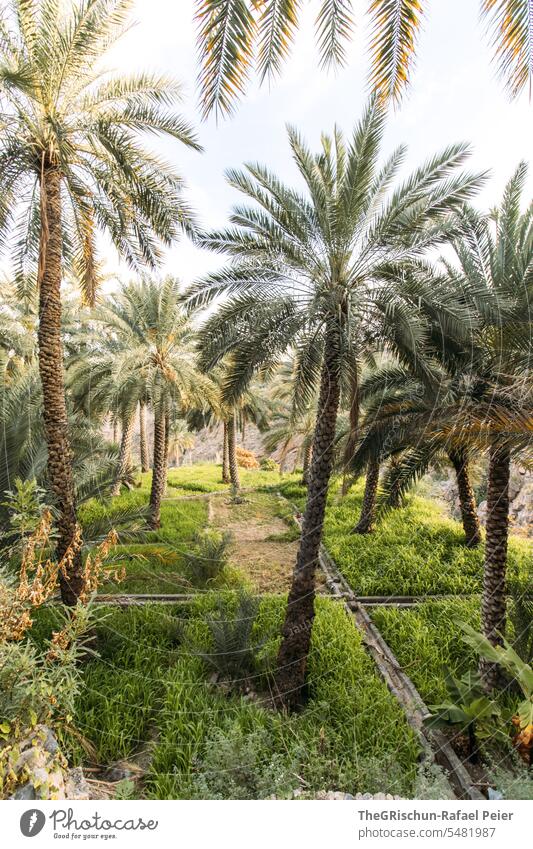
[{"x1": 0, "y1": 0, "x2": 202, "y2": 604}]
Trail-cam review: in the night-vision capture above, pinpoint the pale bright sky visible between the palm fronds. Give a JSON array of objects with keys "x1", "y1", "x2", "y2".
[{"x1": 105, "y1": 0, "x2": 533, "y2": 284}]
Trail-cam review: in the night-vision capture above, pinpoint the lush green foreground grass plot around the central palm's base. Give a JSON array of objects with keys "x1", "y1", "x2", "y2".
[{"x1": 46, "y1": 593, "x2": 418, "y2": 798}]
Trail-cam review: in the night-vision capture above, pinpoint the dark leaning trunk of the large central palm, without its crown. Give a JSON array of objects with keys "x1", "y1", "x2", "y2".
[{"x1": 275, "y1": 334, "x2": 340, "y2": 710}]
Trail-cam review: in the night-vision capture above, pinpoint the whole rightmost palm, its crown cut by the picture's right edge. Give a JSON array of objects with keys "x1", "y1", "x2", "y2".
[{"x1": 448, "y1": 169, "x2": 533, "y2": 687}]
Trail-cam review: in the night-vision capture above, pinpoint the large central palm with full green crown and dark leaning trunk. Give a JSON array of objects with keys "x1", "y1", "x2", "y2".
[{"x1": 188, "y1": 101, "x2": 480, "y2": 707}]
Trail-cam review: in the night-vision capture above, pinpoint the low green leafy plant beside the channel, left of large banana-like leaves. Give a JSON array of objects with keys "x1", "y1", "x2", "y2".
[{"x1": 425, "y1": 672, "x2": 499, "y2": 763}]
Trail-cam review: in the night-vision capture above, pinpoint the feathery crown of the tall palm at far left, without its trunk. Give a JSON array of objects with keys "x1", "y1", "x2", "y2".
[{"x1": 0, "y1": 0, "x2": 198, "y2": 292}]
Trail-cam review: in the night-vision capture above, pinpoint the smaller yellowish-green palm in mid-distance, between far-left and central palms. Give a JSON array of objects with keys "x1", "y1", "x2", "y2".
[{"x1": 70, "y1": 277, "x2": 215, "y2": 528}]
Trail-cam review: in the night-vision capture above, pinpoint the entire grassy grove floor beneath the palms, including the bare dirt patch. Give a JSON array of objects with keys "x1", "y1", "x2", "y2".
[{"x1": 34, "y1": 465, "x2": 528, "y2": 799}]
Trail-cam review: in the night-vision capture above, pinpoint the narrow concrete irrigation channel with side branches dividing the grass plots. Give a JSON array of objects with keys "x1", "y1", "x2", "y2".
[{"x1": 80, "y1": 488, "x2": 485, "y2": 800}]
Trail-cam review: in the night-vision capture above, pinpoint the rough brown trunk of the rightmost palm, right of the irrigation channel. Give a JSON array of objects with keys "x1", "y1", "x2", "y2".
[{"x1": 480, "y1": 445, "x2": 511, "y2": 689}]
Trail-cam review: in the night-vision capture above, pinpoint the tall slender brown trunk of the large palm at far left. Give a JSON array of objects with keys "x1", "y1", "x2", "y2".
[{"x1": 38, "y1": 167, "x2": 83, "y2": 605}]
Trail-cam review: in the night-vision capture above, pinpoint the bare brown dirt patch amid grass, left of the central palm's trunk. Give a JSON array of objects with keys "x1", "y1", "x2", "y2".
[{"x1": 209, "y1": 492, "x2": 298, "y2": 592}]
